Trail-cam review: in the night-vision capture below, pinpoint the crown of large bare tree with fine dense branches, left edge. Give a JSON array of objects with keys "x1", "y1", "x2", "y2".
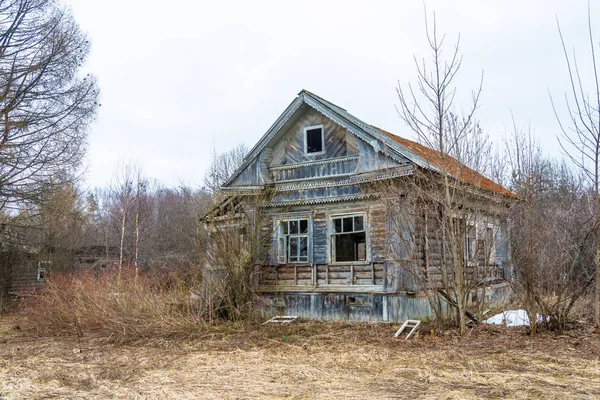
[{"x1": 0, "y1": 0, "x2": 98, "y2": 216}]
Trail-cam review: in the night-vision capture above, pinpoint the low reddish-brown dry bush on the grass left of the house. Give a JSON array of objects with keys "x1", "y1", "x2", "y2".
[{"x1": 24, "y1": 269, "x2": 206, "y2": 343}]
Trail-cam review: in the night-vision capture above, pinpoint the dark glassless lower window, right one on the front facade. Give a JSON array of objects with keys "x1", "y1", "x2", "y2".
[{"x1": 331, "y1": 215, "x2": 367, "y2": 262}]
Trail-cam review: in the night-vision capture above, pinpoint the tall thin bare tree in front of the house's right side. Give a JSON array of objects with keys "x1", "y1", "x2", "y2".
[{"x1": 397, "y1": 10, "x2": 494, "y2": 334}]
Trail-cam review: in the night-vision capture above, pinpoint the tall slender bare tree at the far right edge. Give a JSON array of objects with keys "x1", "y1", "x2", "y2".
[{"x1": 550, "y1": 3, "x2": 600, "y2": 326}]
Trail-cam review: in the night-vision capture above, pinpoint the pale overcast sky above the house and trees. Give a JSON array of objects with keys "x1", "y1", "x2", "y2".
[{"x1": 64, "y1": 0, "x2": 600, "y2": 186}]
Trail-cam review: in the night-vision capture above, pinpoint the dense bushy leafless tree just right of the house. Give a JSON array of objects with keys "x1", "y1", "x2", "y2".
[{"x1": 506, "y1": 123, "x2": 595, "y2": 335}]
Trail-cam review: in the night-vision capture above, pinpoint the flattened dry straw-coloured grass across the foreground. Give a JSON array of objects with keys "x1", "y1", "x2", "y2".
[{"x1": 0, "y1": 317, "x2": 600, "y2": 399}]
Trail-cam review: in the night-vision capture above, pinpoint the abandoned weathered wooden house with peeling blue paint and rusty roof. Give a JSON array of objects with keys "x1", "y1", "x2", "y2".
[{"x1": 208, "y1": 90, "x2": 514, "y2": 321}]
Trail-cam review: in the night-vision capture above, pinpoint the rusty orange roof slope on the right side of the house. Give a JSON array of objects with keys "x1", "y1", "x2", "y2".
[{"x1": 376, "y1": 128, "x2": 516, "y2": 197}]
